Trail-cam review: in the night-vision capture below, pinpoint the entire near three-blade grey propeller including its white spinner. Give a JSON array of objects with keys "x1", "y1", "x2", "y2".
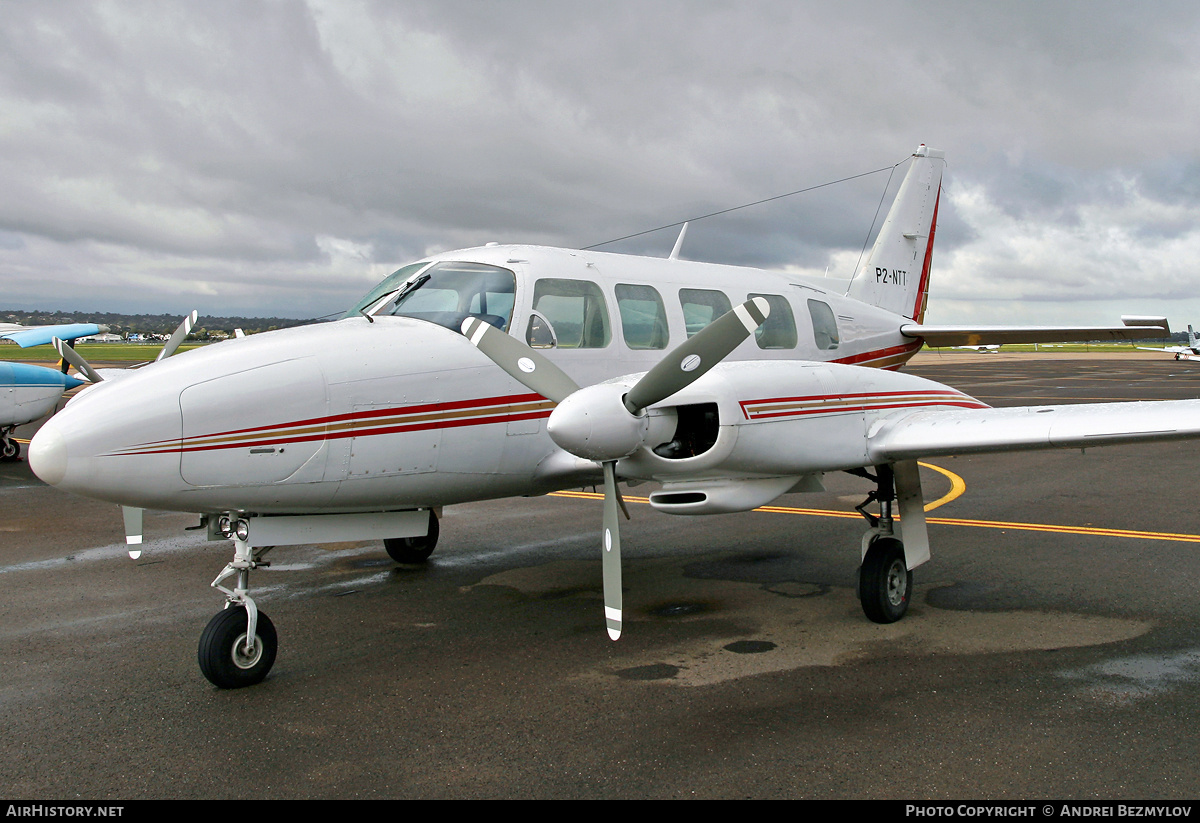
[{"x1": 462, "y1": 298, "x2": 770, "y2": 639}]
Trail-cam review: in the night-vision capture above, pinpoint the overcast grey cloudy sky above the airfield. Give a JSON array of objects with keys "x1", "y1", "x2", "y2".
[{"x1": 0, "y1": 0, "x2": 1200, "y2": 328}]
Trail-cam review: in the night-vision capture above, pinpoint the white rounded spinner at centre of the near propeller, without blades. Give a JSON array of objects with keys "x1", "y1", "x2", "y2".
[{"x1": 546, "y1": 383, "x2": 649, "y2": 462}]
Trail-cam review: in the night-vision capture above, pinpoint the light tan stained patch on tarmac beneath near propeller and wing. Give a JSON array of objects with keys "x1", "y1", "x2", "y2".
[{"x1": 464, "y1": 557, "x2": 1147, "y2": 686}]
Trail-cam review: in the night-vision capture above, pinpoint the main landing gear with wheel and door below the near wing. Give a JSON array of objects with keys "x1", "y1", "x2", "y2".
[{"x1": 851, "y1": 461, "x2": 929, "y2": 623}]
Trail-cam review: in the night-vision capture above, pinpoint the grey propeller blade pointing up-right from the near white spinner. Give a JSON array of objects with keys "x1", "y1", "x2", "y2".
[{"x1": 625, "y1": 298, "x2": 770, "y2": 414}]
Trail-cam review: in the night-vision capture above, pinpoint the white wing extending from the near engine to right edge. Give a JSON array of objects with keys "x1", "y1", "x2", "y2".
[{"x1": 868, "y1": 400, "x2": 1200, "y2": 463}]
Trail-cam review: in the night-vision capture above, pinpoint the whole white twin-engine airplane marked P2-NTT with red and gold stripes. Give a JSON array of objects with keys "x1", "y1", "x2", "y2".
[{"x1": 29, "y1": 145, "x2": 1200, "y2": 687}]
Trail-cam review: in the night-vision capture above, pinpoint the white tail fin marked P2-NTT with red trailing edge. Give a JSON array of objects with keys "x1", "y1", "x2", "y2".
[{"x1": 846, "y1": 143, "x2": 946, "y2": 323}]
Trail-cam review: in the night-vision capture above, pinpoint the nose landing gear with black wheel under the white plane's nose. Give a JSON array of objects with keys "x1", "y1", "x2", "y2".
[{"x1": 197, "y1": 527, "x2": 278, "y2": 689}]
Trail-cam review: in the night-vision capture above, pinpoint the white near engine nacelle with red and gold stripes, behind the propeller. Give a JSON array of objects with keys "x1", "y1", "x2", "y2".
[{"x1": 620, "y1": 360, "x2": 979, "y2": 489}]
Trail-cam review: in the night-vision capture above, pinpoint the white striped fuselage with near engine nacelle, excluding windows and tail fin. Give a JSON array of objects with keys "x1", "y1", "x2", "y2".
[{"x1": 31, "y1": 246, "x2": 974, "y2": 513}]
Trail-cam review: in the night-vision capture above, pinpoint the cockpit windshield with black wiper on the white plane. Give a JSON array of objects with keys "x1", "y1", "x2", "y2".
[{"x1": 346, "y1": 262, "x2": 516, "y2": 331}]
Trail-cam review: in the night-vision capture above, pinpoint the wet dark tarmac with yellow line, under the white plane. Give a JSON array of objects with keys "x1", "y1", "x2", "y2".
[{"x1": 0, "y1": 353, "x2": 1200, "y2": 800}]
